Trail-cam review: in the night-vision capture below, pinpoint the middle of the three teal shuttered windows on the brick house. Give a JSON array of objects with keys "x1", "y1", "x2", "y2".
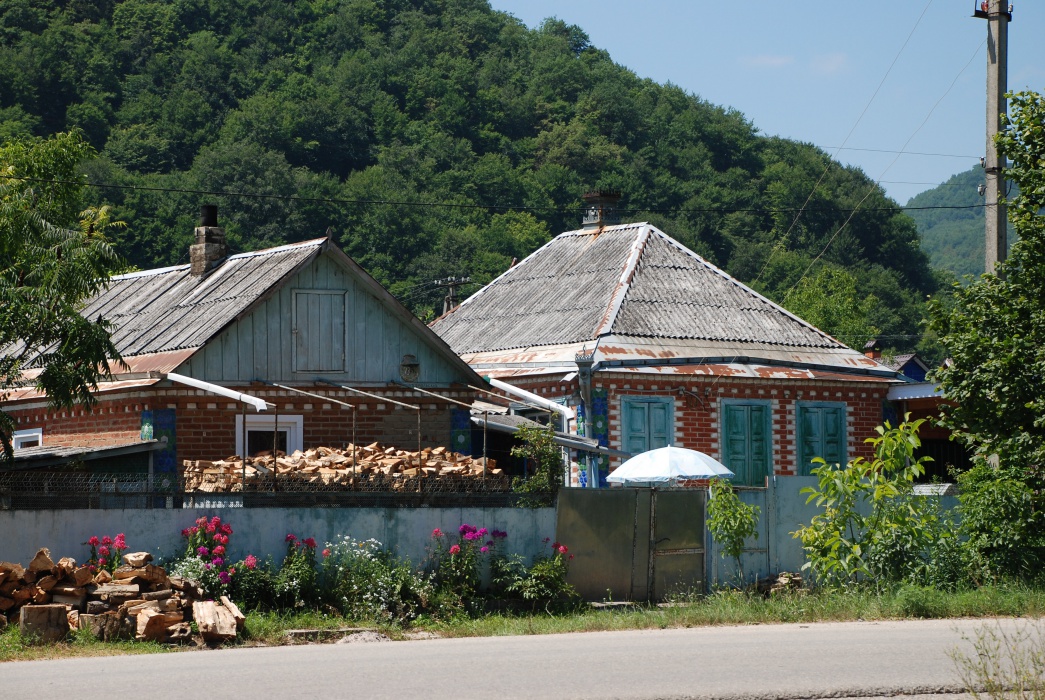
[{"x1": 722, "y1": 400, "x2": 772, "y2": 486}]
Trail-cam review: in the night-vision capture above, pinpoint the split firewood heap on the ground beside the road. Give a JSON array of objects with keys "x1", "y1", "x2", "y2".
[{"x1": 0, "y1": 549, "x2": 243, "y2": 644}]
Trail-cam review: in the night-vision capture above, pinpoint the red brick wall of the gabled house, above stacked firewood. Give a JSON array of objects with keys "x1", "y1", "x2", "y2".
[{"x1": 6, "y1": 388, "x2": 473, "y2": 463}]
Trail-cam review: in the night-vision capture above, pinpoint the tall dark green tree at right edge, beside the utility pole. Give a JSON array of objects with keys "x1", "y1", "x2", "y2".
[{"x1": 930, "y1": 92, "x2": 1045, "y2": 480}]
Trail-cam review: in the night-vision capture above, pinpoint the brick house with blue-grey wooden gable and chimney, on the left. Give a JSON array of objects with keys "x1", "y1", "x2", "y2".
[{"x1": 2, "y1": 207, "x2": 482, "y2": 482}]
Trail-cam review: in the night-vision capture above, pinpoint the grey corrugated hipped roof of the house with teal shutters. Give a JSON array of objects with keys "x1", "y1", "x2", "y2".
[{"x1": 432, "y1": 224, "x2": 846, "y2": 354}]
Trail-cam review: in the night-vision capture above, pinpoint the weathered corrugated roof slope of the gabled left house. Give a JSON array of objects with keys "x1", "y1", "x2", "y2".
[{"x1": 83, "y1": 238, "x2": 326, "y2": 357}]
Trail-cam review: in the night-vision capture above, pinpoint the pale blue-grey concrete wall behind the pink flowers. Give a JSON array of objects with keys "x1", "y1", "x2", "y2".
[{"x1": 0, "y1": 508, "x2": 555, "y2": 564}]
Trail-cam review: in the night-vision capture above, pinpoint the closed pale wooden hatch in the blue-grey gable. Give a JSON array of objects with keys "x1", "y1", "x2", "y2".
[{"x1": 293, "y1": 289, "x2": 345, "y2": 372}]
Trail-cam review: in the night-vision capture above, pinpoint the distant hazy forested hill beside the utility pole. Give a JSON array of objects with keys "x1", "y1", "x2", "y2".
[{"x1": 907, "y1": 165, "x2": 1015, "y2": 278}]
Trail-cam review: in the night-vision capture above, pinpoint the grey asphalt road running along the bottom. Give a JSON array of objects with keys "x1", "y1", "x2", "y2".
[{"x1": 0, "y1": 621, "x2": 1014, "y2": 700}]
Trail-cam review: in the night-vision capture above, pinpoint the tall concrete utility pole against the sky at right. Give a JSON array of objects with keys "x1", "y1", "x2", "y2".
[{"x1": 973, "y1": 0, "x2": 1013, "y2": 275}]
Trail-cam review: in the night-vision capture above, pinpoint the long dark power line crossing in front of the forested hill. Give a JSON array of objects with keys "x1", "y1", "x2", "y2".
[{"x1": 0, "y1": 174, "x2": 984, "y2": 214}]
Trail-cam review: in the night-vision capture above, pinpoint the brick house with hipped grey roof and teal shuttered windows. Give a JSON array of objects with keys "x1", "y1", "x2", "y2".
[{"x1": 432, "y1": 193, "x2": 904, "y2": 486}]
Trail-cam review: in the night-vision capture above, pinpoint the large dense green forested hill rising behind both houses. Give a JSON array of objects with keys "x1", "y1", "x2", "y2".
[{"x1": 0, "y1": 0, "x2": 934, "y2": 347}]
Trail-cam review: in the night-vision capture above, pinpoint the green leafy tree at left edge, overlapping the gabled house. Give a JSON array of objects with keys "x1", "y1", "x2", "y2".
[{"x1": 0, "y1": 133, "x2": 120, "y2": 461}]
